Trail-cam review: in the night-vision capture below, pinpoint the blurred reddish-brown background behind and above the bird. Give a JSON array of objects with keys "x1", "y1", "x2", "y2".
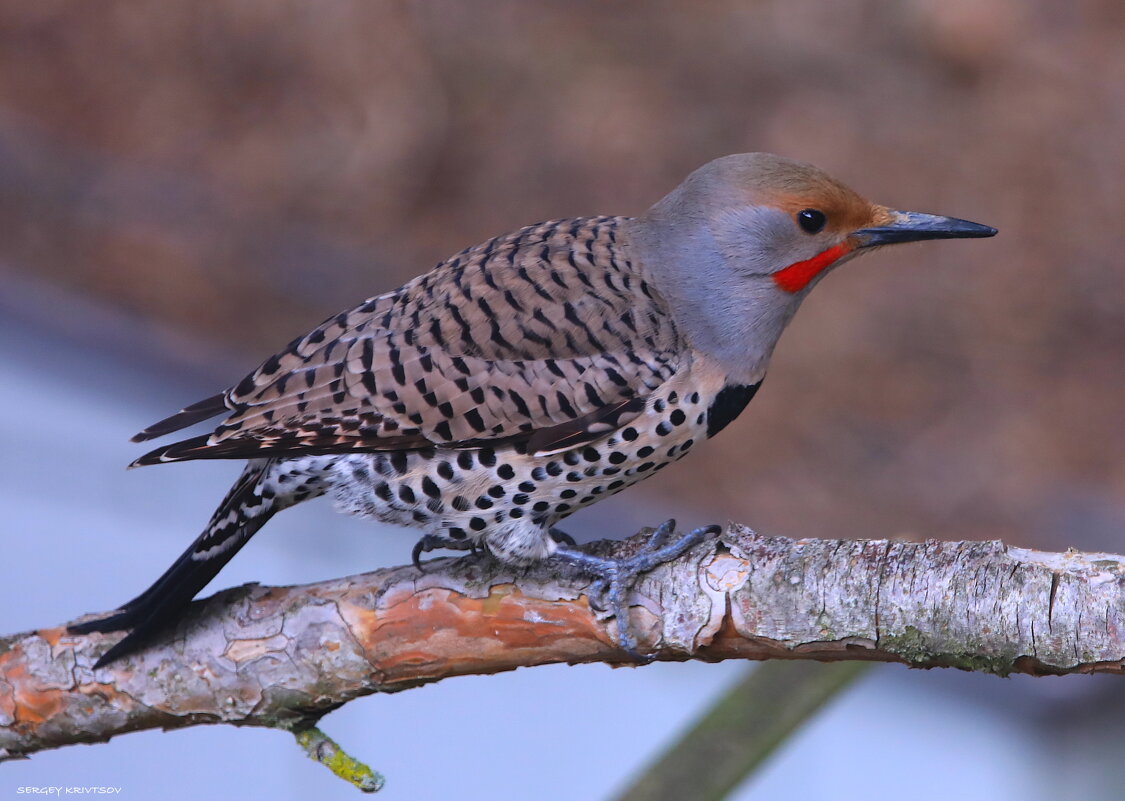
[{"x1": 0, "y1": 0, "x2": 1125, "y2": 551}]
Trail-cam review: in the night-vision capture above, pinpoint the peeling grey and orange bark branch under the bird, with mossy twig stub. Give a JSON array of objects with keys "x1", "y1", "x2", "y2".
[{"x1": 0, "y1": 525, "x2": 1125, "y2": 769}]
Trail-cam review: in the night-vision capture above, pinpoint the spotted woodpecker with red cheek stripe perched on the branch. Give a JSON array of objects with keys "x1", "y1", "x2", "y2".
[{"x1": 70, "y1": 153, "x2": 997, "y2": 667}]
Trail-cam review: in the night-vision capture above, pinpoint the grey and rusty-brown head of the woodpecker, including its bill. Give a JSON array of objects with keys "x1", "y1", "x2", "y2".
[{"x1": 633, "y1": 153, "x2": 997, "y2": 378}]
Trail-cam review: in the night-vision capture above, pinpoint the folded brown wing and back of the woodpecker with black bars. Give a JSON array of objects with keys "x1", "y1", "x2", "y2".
[{"x1": 136, "y1": 217, "x2": 683, "y2": 464}]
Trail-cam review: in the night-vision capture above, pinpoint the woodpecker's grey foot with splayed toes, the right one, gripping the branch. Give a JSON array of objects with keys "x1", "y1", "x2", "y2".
[{"x1": 551, "y1": 520, "x2": 722, "y2": 663}]
